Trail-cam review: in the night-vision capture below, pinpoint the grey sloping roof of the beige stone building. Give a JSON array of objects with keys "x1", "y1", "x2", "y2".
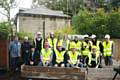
[{"x1": 19, "y1": 6, "x2": 70, "y2": 18}]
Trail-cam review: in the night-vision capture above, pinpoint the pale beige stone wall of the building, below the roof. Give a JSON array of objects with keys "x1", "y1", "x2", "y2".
[{"x1": 18, "y1": 16, "x2": 70, "y2": 34}]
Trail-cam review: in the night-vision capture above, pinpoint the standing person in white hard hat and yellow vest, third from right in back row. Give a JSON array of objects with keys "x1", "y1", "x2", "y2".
[{"x1": 81, "y1": 35, "x2": 92, "y2": 63}]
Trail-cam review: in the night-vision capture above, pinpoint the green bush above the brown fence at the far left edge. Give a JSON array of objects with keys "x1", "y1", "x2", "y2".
[{"x1": 0, "y1": 22, "x2": 11, "y2": 39}]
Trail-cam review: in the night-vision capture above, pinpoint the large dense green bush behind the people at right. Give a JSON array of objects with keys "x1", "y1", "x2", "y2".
[{"x1": 72, "y1": 9, "x2": 120, "y2": 38}]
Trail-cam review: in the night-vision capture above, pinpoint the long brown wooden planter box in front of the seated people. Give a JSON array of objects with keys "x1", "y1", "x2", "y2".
[{"x1": 21, "y1": 65, "x2": 85, "y2": 80}]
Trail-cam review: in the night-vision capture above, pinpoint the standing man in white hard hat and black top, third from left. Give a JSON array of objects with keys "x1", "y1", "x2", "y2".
[{"x1": 33, "y1": 32, "x2": 43, "y2": 53}]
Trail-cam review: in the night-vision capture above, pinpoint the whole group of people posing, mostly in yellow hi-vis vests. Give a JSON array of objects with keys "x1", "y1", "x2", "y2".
[{"x1": 9, "y1": 32, "x2": 113, "y2": 69}]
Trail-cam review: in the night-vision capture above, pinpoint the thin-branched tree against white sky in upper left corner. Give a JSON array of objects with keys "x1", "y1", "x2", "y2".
[{"x1": 0, "y1": 0, "x2": 16, "y2": 21}]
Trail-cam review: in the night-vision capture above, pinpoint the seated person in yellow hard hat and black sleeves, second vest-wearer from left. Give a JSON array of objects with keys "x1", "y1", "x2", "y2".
[{"x1": 53, "y1": 41, "x2": 66, "y2": 67}]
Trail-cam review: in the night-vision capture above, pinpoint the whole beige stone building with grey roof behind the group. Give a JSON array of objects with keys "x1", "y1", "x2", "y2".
[{"x1": 16, "y1": 6, "x2": 71, "y2": 34}]
